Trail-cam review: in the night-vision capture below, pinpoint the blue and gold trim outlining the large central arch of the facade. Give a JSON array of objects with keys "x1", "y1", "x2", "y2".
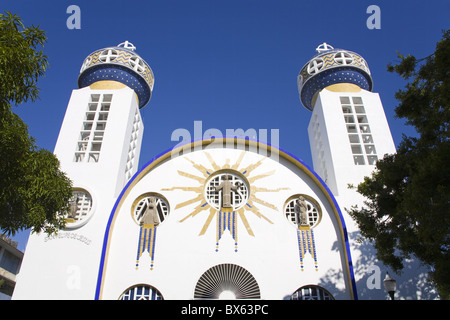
[{"x1": 95, "y1": 137, "x2": 358, "y2": 300}]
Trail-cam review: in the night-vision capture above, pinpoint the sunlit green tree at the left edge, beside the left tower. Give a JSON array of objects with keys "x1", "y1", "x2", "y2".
[{"x1": 0, "y1": 12, "x2": 72, "y2": 234}]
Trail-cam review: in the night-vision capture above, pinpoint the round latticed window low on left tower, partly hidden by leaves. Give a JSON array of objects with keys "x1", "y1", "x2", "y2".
[{"x1": 65, "y1": 188, "x2": 93, "y2": 228}]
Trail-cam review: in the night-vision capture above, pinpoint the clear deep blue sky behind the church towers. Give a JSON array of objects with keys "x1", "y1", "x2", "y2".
[{"x1": 1, "y1": 0, "x2": 450, "y2": 250}]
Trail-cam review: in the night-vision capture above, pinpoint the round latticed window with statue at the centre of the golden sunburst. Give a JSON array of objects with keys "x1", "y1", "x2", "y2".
[{"x1": 205, "y1": 172, "x2": 249, "y2": 210}]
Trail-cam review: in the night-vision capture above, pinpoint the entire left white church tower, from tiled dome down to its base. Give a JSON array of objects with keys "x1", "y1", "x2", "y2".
[{"x1": 14, "y1": 41, "x2": 154, "y2": 299}]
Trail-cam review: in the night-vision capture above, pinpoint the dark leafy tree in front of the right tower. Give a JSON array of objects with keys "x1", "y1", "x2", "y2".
[{"x1": 348, "y1": 30, "x2": 450, "y2": 299}]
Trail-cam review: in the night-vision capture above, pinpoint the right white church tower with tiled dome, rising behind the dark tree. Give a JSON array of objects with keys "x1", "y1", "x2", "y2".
[{"x1": 297, "y1": 43, "x2": 396, "y2": 196}]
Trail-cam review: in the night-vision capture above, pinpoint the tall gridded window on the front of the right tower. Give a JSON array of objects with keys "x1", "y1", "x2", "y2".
[{"x1": 340, "y1": 97, "x2": 378, "y2": 165}]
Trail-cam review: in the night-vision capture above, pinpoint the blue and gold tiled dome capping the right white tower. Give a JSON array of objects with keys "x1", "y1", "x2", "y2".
[{"x1": 297, "y1": 43, "x2": 373, "y2": 110}]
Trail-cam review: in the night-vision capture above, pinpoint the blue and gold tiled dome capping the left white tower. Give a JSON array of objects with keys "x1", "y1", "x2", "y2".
[{"x1": 78, "y1": 41, "x2": 155, "y2": 108}]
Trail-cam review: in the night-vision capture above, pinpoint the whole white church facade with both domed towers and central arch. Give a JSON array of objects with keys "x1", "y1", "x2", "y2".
[{"x1": 13, "y1": 42, "x2": 438, "y2": 300}]
